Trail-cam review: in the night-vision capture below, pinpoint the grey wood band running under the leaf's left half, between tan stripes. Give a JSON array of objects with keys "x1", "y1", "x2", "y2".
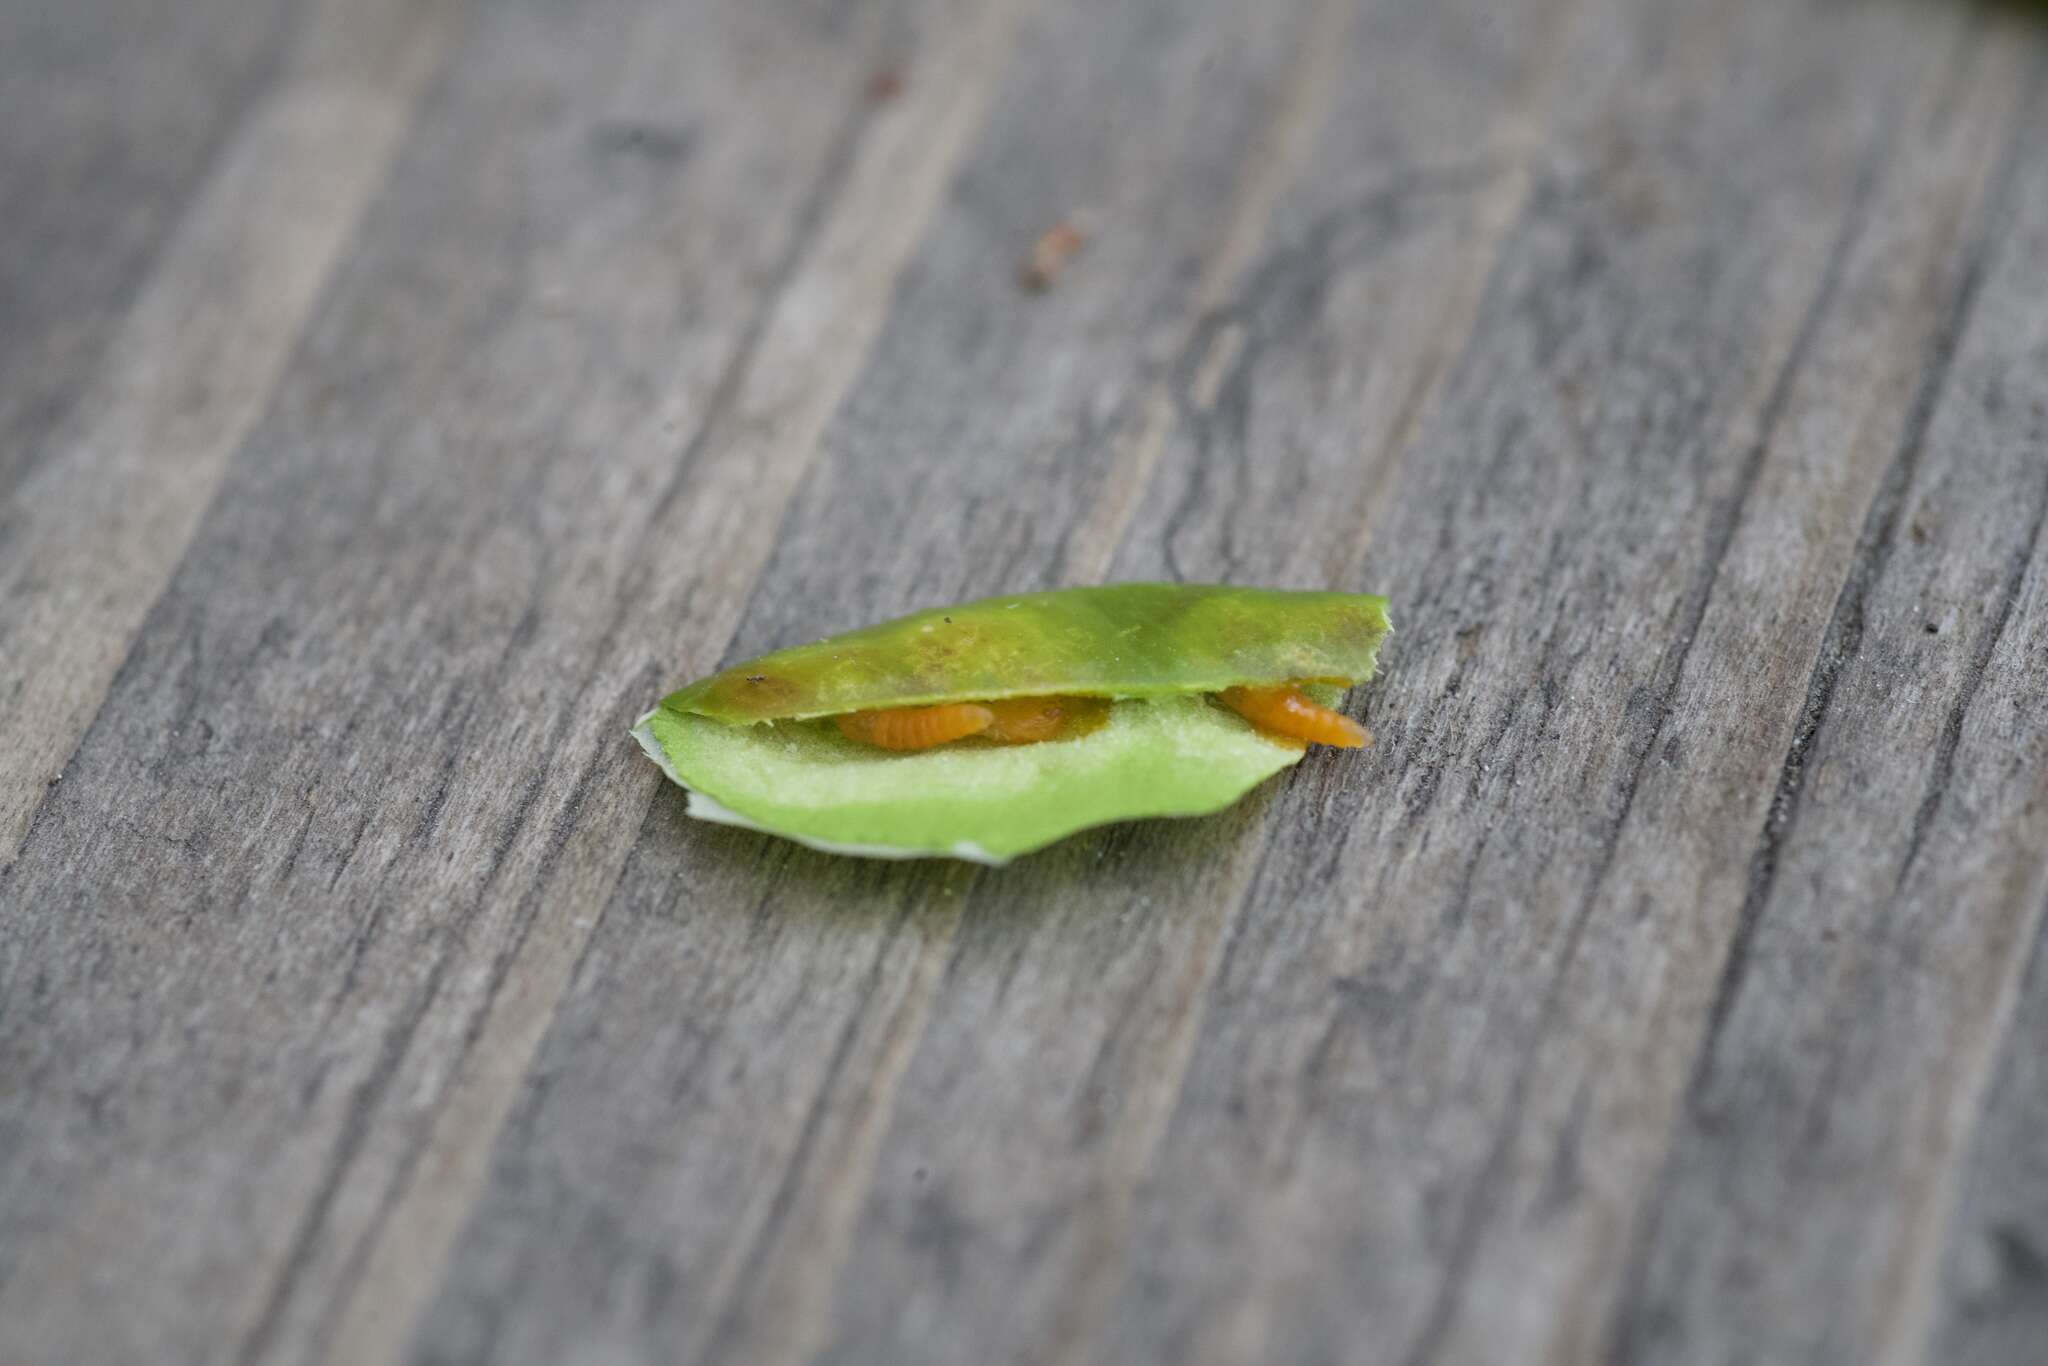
[{"x1": 403, "y1": 4, "x2": 1392, "y2": 1360}]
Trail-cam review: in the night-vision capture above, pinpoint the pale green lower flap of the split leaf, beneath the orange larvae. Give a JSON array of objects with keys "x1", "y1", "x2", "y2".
[{"x1": 635, "y1": 696, "x2": 1303, "y2": 862}]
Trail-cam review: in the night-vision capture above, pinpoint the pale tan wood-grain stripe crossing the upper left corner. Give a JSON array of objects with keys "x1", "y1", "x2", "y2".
[{"x1": 0, "y1": 0, "x2": 453, "y2": 866}]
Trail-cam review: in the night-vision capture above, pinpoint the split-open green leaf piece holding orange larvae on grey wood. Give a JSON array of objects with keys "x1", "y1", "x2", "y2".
[{"x1": 633, "y1": 584, "x2": 1389, "y2": 864}]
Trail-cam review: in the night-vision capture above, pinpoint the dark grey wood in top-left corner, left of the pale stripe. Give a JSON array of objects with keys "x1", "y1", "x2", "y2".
[{"x1": 0, "y1": 0, "x2": 309, "y2": 498}]
